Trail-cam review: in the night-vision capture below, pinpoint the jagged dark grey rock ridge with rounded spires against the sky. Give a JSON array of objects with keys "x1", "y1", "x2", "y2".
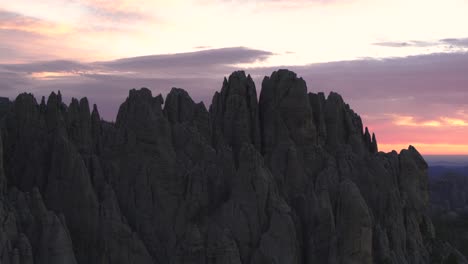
[{"x1": 0, "y1": 70, "x2": 466, "y2": 264}]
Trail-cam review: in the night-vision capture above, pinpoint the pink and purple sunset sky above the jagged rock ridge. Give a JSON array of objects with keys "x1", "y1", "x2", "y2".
[{"x1": 0, "y1": 0, "x2": 468, "y2": 155}]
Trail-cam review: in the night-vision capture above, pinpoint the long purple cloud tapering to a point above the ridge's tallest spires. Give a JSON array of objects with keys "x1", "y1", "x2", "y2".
[{"x1": 0, "y1": 47, "x2": 273, "y2": 79}]
